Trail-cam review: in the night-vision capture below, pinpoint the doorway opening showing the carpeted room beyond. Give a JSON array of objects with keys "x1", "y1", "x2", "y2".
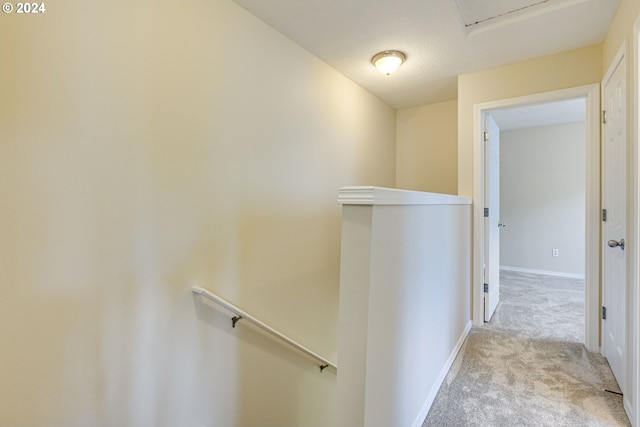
[{"x1": 485, "y1": 97, "x2": 586, "y2": 343}]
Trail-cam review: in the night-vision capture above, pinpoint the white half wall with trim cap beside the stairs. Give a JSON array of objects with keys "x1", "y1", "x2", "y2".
[{"x1": 336, "y1": 187, "x2": 471, "y2": 427}]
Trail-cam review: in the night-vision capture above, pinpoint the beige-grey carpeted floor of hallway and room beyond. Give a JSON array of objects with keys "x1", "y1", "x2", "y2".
[{"x1": 423, "y1": 271, "x2": 630, "y2": 427}]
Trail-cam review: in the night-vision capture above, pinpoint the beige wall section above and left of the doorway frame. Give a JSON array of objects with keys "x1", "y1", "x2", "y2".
[{"x1": 458, "y1": 45, "x2": 602, "y2": 196}]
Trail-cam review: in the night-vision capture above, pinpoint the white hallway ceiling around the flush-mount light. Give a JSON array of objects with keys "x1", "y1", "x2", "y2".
[{"x1": 234, "y1": 0, "x2": 620, "y2": 109}]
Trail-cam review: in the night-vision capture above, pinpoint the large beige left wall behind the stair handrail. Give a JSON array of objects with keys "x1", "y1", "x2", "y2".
[{"x1": 0, "y1": 0, "x2": 396, "y2": 427}]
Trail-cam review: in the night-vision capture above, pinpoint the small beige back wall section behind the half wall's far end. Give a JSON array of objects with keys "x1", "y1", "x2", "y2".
[{"x1": 396, "y1": 100, "x2": 458, "y2": 194}]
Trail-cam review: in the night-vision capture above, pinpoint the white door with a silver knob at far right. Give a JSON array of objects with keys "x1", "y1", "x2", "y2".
[{"x1": 602, "y1": 51, "x2": 627, "y2": 390}]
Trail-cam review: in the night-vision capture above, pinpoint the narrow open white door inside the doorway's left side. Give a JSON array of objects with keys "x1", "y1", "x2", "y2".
[{"x1": 484, "y1": 114, "x2": 500, "y2": 322}]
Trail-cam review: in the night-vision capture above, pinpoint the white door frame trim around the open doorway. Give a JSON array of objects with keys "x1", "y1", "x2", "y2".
[{"x1": 471, "y1": 83, "x2": 600, "y2": 352}]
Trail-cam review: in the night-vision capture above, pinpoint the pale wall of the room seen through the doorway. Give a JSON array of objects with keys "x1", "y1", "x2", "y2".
[{"x1": 500, "y1": 122, "x2": 586, "y2": 276}]
